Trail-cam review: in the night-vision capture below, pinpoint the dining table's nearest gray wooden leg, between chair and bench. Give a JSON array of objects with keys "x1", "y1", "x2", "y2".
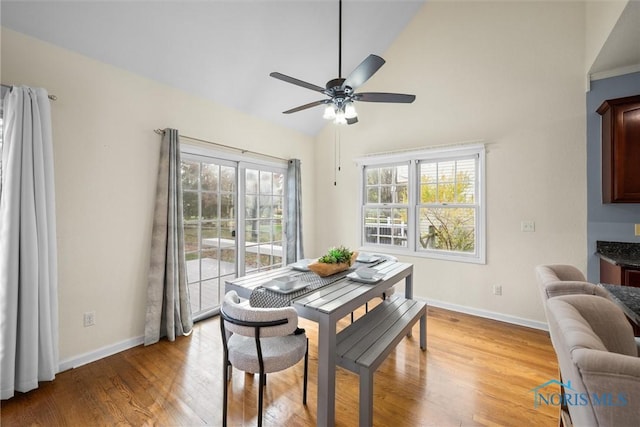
[{"x1": 317, "y1": 316, "x2": 336, "y2": 427}]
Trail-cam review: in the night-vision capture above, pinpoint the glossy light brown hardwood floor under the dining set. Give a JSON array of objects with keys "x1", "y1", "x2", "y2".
[{"x1": 0, "y1": 308, "x2": 558, "y2": 427}]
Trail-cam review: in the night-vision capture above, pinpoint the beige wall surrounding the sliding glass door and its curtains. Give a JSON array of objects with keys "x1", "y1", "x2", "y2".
[{"x1": 2, "y1": 28, "x2": 314, "y2": 361}]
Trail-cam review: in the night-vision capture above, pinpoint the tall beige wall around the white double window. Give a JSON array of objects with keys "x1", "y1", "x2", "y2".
[{"x1": 315, "y1": 2, "x2": 587, "y2": 323}]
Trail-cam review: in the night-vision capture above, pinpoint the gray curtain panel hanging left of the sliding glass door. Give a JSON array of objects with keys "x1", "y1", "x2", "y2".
[{"x1": 144, "y1": 129, "x2": 193, "y2": 345}]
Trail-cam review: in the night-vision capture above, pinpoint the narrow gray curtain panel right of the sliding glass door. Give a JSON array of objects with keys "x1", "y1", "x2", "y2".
[{"x1": 286, "y1": 159, "x2": 304, "y2": 264}]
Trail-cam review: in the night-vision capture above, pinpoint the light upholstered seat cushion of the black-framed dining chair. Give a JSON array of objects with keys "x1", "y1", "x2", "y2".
[{"x1": 227, "y1": 334, "x2": 307, "y2": 374}]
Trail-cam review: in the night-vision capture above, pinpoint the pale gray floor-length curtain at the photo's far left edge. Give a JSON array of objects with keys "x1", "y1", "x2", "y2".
[{"x1": 0, "y1": 87, "x2": 58, "y2": 399}]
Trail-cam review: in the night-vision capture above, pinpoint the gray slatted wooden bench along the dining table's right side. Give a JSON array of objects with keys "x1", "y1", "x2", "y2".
[{"x1": 336, "y1": 296, "x2": 427, "y2": 426}]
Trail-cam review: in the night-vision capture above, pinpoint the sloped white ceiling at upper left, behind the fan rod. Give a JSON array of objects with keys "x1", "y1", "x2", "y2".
[{"x1": 0, "y1": 0, "x2": 425, "y2": 135}]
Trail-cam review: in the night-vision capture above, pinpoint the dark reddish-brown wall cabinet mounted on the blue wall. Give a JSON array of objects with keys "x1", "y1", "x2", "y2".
[{"x1": 597, "y1": 95, "x2": 640, "y2": 203}]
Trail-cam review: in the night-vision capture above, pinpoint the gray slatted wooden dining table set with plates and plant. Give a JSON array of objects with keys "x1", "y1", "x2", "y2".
[{"x1": 225, "y1": 254, "x2": 413, "y2": 426}]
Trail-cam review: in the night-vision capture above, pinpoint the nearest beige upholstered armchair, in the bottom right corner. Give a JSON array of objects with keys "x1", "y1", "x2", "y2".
[{"x1": 546, "y1": 295, "x2": 640, "y2": 427}]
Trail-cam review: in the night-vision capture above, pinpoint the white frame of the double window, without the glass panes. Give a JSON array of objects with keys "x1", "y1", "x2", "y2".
[{"x1": 355, "y1": 143, "x2": 487, "y2": 264}]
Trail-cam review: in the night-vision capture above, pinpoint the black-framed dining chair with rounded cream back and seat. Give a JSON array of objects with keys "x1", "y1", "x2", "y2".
[{"x1": 220, "y1": 291, "x2": 309, "y2": 427}]
